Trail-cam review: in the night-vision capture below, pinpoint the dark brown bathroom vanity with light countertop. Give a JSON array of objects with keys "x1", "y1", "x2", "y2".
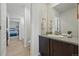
[{"x1": 39, "y1": 35, "x2": 78, "y2": 56}]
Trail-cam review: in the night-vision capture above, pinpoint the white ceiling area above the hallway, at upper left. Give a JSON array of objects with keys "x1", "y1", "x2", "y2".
[{"x1": 7, "y1": 3, "x2": 30, "y2": 16}]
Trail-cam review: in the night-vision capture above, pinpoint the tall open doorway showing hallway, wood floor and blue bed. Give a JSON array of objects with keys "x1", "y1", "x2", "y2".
[{"x1": 6, "y1": 3, "x2": 30, "y2": 56}]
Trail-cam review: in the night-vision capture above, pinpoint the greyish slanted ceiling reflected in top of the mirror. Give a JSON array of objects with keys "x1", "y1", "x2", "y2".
[{"x1": 53, "y1": 3, "x2": 77, "y2": 13}]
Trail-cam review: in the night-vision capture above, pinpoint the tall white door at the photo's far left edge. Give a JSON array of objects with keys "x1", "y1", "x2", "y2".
[{"x1": 0, "y1": 3, "x2": 6, "y2": 56}]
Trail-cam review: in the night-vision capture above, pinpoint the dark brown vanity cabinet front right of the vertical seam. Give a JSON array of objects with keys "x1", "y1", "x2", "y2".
[{"x1": 50, "y1": 40, "x2": 78, "y2": 56}]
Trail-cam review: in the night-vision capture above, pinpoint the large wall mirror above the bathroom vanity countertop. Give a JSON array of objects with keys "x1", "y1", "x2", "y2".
[{"x1": 51, "y1": 3, "x2": 77, "y2": 36}]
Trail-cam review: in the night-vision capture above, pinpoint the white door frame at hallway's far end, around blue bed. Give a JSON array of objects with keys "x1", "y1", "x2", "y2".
[{"x1": 8, "y1": 16, "x2": 25, "y2": 45}]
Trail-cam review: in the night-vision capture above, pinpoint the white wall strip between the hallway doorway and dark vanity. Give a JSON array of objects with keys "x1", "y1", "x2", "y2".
[{"x1": 31, "y1": 3, "x2": 45, "y2": 56}]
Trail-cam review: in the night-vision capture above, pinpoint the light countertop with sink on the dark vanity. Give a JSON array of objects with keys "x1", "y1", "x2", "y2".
[{"x1": 40, "y1": 35, "x2": 79, "y2": 45}]
